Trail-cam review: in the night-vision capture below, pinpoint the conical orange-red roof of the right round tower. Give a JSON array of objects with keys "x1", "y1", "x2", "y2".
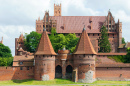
[{"x1": 73, "y1": 27, "x2": 97, "y2": 54}]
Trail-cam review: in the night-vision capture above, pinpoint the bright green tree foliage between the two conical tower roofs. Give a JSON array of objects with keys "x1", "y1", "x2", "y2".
[{"x1": 49, "y1": 28, "x2": 79, "y2": 53}]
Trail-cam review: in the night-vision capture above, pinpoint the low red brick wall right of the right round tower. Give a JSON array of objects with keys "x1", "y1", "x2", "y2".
[{"x1": 96, "y1": 67, "x2": 130, "y2": 80}]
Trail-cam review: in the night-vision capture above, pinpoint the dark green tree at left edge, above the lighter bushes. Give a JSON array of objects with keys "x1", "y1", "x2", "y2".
[{"x1": 0, "y1": 43, "x2": 12, "y2": 58}]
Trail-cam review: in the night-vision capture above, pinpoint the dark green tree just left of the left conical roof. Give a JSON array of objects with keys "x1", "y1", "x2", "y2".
[{"x1": 24, "y1": 31, "x2": 41, "y2": 53}]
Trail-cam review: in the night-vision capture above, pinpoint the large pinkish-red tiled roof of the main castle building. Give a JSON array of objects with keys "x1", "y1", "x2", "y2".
[{"x1": 50, "y1": 16, "x2": 106, "y2": 33}]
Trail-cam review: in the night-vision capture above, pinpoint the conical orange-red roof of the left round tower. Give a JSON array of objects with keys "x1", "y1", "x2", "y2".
[{"x1": 35, "y1": 29, "x2": 57, "y2": 55}]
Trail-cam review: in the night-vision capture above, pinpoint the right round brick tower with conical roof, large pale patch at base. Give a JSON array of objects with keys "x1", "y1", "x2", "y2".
[{"x1": 73, "y1": 27, "x2": 97, "y2": 83}]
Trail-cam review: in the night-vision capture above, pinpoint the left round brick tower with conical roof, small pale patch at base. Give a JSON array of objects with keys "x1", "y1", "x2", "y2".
[{"x1": 34, "y1": 28, "x2": 57, "y2": 81}]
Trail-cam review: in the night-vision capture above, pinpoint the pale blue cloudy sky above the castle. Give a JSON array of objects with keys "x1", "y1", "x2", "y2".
[{"x1": 0, "y1": 0, "x2": 130, "y2": 56}]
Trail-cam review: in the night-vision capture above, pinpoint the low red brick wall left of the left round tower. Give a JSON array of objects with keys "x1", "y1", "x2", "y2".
[{"x1": 0, "y1": 67, "x2": 34, "y2": 81}]
